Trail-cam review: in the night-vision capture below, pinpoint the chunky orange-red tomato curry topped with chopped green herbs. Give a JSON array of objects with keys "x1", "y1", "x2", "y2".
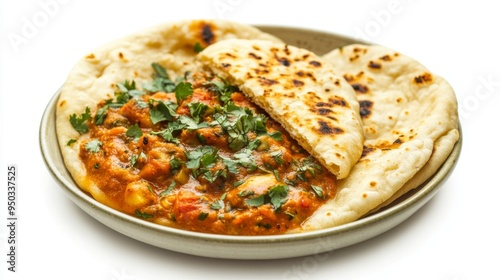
[{"x1": 70, "y1": 63, "x2": 335, "y2": 235}]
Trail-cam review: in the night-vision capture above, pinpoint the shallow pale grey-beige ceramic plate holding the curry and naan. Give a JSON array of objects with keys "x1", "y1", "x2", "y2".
[{"x1": 39, "y1": 26, "x2": 462, "y2": 259}]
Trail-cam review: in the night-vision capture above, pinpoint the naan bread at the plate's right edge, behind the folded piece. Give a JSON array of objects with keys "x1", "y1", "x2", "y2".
[{"x1": 302, "y1": 44, "x2": 459, "y2": 230}]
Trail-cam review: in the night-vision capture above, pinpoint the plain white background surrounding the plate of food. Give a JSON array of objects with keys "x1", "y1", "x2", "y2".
[{"x1": 0, "y1": 0, "x2": 500, "y2": 280}]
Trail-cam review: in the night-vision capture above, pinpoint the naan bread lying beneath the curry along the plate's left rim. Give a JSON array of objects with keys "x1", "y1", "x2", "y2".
[{"x1": 56, "y1": 20, "x2": 280, "y2": 204}]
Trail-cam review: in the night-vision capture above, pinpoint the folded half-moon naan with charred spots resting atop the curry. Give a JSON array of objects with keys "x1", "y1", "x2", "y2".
[{"x1": 198, "y1": 39, "x2": 363, "y2": 179}]
